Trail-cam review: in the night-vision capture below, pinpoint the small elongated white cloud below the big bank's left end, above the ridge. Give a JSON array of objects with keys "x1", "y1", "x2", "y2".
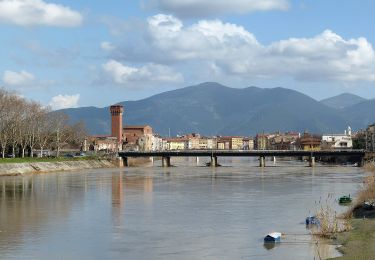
[{"x1": 102, "y1": 60, "x2": 183, "y2": 85}]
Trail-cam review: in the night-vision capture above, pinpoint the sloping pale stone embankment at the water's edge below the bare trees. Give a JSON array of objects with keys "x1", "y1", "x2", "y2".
[{"x1": 0, "y1": 160, "x2": 117, "y2": 176}]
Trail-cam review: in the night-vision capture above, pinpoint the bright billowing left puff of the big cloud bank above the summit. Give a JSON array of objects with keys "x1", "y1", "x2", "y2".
[{"x1": 148, "y1": 14, "x2": 259, "y2": 60}]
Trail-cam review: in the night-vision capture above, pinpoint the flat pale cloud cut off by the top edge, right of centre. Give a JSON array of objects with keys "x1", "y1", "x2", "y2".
[{"x1": 147, "y1": 0, "x2": 289, "y2": 17}]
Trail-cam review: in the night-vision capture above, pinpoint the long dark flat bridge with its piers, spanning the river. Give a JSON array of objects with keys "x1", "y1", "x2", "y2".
[{"x1": 118, "y1": 150, "x2": 366, "y2": 167}]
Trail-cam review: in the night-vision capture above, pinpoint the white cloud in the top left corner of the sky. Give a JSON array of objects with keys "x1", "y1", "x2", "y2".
[{"x1": 0, "y1": 0, "x2": 83, "y2": 27}]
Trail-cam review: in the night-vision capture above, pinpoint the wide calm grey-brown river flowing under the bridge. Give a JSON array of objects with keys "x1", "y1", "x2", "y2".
[{"x1": 0, "y1": 158, "x2": 364, "y2": 259}]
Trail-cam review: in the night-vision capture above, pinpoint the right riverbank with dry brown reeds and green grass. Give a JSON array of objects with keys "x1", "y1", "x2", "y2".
[{"x1": 335, "y1": 163, "x2": 375, "y2": 260}]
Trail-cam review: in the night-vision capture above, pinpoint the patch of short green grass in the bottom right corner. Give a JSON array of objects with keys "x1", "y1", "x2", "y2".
[{"x1": 335, "y1": 219, "x2": 375, "y2": 260}]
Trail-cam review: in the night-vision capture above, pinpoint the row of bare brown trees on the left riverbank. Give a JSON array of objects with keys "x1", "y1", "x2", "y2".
[{"x1": 0, "y1": 89, "x2": 86, "y2": 158}]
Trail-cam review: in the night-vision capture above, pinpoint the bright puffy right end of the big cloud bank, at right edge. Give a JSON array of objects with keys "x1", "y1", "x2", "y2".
[{"x1": 264, "y1": 30, "x2": 375, "y2": 81}]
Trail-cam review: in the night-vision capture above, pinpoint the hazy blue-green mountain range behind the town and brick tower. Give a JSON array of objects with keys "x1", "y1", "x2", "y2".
[{"x1": 56, "y1": 82, "x2": 375, "y2": 136}]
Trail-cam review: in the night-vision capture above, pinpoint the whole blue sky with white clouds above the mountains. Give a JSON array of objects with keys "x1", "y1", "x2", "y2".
[{"x1": 0, "y1": 0, "x2": 375, "y2": 109}]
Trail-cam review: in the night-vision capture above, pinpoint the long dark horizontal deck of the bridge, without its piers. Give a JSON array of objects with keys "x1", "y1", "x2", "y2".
[{"x1": 119, "y1": 150, "x2": 365, "y2": 157}]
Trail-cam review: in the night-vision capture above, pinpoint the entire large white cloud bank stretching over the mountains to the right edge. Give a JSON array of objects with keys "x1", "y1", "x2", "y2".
[{"x1": 112, "y1": 14, "x2": 375, "y2": 82}]
